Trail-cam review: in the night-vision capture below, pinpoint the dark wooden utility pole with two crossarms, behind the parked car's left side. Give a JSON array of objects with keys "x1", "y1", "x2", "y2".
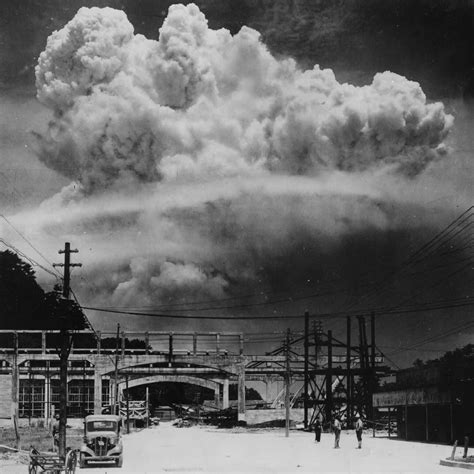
[{"x1": 54, "y1": 242, "x2": 82, "y2": 457}]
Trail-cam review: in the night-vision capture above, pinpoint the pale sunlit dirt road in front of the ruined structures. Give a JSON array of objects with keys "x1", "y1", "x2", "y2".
[{"x1": 0, "y1": 423, "x2": 458, "y2": 474}]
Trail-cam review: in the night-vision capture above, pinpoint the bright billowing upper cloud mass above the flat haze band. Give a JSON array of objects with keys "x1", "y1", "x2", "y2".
[{"x1": 36, "y1": 5, "x2": 451, "y2": 193}]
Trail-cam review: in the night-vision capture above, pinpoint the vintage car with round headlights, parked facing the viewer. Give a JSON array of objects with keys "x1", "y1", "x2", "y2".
[{"x1": 79, "y1": 415, "x2": 123, "y2": 468}]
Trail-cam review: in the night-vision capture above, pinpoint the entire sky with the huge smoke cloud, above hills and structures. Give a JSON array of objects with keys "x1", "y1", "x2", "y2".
[{"x1": 0, "y1": 0, "x2": 474, "y2": 364}]
